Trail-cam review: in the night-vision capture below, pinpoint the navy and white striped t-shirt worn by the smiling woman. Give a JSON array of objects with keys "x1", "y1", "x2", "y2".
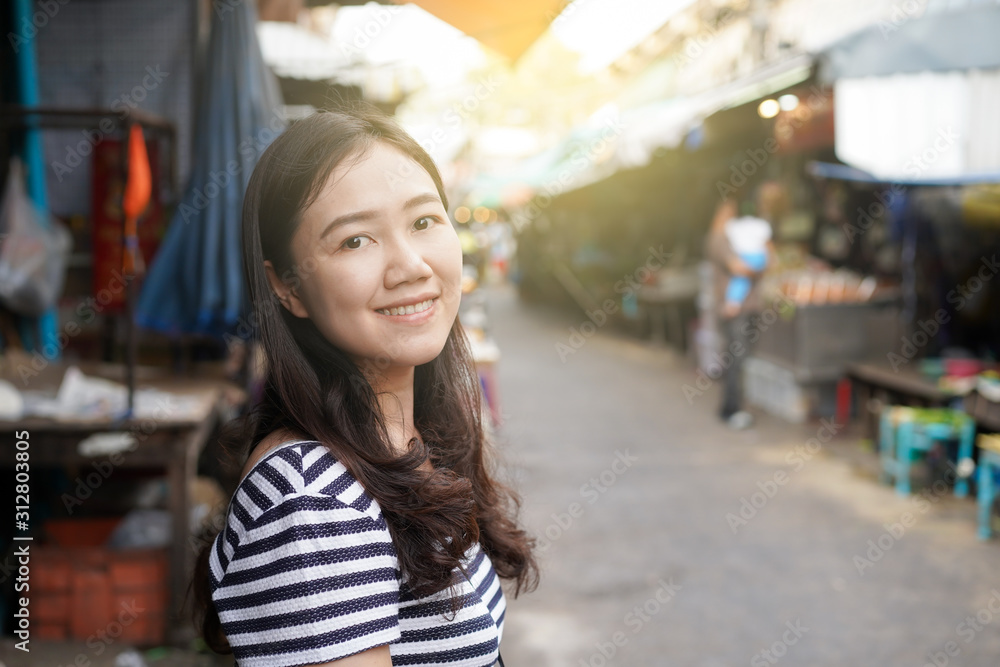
[{"x1": 210, "y1": 441, "x2": 506, "y2": 667}]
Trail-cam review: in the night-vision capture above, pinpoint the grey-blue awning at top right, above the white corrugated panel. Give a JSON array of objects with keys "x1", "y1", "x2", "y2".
[{"x1": 819, "y1": 5, "x2": 1000, "y2": 83}]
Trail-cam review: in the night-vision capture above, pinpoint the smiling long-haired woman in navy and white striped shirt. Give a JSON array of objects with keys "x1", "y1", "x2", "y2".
[{"x1": 194, "y1": 110, "x2": 538, "y2": 667}]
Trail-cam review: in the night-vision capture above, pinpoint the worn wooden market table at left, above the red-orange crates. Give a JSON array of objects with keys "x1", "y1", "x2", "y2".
[{"x1": 0, "y1": 370, "x2": 242, "y2": 628}]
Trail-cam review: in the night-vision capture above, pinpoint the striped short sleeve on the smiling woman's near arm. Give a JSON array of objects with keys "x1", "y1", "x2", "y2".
[{"x1": 213, "y1": 495, "x2": 401, "y2": 667}]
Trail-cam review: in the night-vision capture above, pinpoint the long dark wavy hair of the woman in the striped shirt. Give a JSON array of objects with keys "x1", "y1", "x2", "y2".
[{"x1": 193, "y1": 106, "x2": 538, "y2": 652}]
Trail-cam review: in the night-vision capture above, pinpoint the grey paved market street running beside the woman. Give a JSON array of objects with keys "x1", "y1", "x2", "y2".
[{"x1": 489, "y1": 286, "x2": 1000, "y2": 667}]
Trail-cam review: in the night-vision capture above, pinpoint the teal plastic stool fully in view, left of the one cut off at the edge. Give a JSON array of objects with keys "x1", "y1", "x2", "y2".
[{"x1": 879, "y1": 406, "x2": 976, "y2": 498}]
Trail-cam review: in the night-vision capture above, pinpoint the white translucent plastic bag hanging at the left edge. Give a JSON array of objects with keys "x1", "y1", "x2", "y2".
[{"x1": 0, "y1": 157, "x2": 73, "y2": 317}]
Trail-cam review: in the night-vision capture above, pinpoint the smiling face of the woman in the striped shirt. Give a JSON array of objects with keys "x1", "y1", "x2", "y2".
[{"x1": 267, "y1": 142, "x2": 462, "y2": 369}]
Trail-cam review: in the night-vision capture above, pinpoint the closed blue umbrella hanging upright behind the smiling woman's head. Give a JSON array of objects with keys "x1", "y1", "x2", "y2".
[{"x1": 136, "y1": 0, "x2": 285, "y2": 335}]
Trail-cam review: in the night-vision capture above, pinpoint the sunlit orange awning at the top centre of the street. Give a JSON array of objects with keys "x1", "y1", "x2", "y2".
[{"x1": 398, "y1": 0, "x2": 564, "y2": 61}]
